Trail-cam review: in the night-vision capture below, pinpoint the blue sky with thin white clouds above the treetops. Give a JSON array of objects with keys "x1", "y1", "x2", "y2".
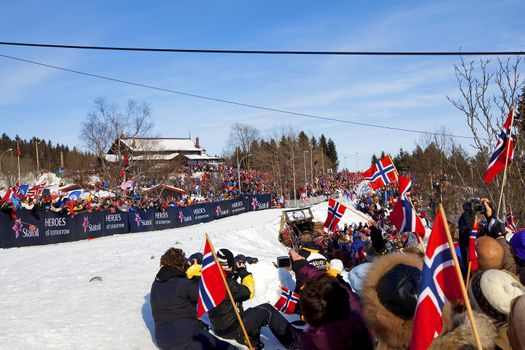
[{"x1": 0, "y1": 0, "x2": 525, "y2": 169}]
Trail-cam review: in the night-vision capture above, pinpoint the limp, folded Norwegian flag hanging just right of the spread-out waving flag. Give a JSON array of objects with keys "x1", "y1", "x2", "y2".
[{"x1": 388, "y1": 175, "x2": 425, "y2": 238}]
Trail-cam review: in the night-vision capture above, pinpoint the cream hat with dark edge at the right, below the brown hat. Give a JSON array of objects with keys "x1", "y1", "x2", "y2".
[{"x1": 468, "y1": 269, "x2": 525, "y2": 322}]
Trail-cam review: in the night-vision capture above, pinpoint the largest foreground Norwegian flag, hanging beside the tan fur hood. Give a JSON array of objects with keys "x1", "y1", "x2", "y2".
[{"x1": 410, "y1": 212, "x2": 463, "y2": 350}]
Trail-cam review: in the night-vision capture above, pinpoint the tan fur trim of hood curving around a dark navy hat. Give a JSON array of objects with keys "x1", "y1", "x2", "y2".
[{"x1": 362, "y1": 253, "x2": 423, "y2": 349}]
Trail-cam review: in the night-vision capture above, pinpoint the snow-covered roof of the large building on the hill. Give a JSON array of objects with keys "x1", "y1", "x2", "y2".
[{"x1": 121, "y1": 137, "x2": 204, "y2": 152}]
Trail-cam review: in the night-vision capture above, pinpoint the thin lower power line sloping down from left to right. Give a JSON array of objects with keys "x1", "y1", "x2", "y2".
[{"x1": 0, "y1": 54, "x2": 474, "y2": 139}]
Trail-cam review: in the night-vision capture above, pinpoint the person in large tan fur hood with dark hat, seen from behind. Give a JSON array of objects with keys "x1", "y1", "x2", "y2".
[{"x1": 361, "y1": 249, "x2": 423, "y2": 350}]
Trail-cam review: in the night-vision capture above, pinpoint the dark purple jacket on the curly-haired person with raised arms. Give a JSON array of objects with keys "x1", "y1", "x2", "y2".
[{"x1": 293, "y1": 260, "x2": 374, "y2": 350}]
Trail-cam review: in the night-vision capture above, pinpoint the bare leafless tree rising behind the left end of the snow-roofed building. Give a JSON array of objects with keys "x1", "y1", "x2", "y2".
[{"x1": 80, "y1": 98, "x2": 153, "y2": 178}]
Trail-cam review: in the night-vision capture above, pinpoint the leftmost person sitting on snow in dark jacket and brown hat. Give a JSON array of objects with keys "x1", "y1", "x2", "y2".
[{"x1": 150, "y1": 248, "x2": 236, "y2": 350}]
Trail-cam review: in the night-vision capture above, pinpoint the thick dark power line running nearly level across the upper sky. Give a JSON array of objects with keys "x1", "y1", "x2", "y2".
[{"x1": 0, "y1": 41, "x2": 525, "y2": 56}]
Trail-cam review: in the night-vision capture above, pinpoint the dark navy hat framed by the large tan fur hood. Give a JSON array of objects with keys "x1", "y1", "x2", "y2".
[{"x1": 377, "y1": 264, "x2": 421, "y2": 320}]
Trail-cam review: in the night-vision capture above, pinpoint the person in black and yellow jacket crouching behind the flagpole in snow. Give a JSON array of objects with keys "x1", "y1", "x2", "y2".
[{"x1": 208, "y1": 249, "x2": 296, "y2": 349}]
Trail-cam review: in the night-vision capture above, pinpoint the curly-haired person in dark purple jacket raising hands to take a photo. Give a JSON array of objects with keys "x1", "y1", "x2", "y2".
[{"x1": 290, "y1": 249, "x2": 373, "y2": 350}]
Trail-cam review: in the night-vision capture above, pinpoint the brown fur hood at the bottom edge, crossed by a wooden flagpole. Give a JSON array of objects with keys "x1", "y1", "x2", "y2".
[{"x1": 429, "y1": 303, "x2": 497, "y2": 350}]
